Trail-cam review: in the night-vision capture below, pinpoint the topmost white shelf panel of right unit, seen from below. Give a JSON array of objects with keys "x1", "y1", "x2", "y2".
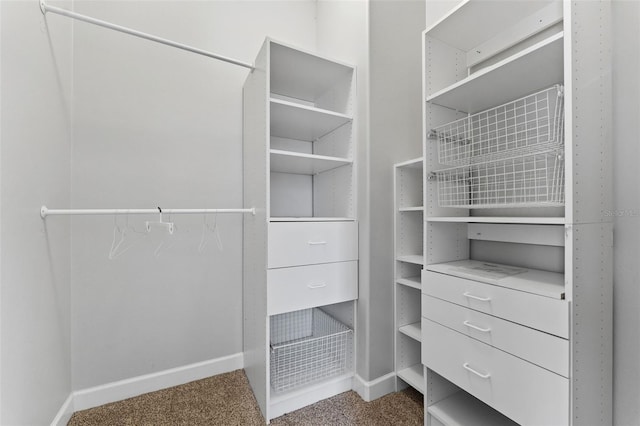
[{"x1": 426, "y1": 0, "x2": 557, "y2": 51}]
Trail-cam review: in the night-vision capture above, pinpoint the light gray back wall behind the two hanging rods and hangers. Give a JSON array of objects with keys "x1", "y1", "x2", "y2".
[{"x1": 72, "y1": 0, "x2": 316, "y2": 389}]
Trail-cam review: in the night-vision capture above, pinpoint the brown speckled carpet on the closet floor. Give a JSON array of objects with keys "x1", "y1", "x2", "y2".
[{"x1": 68, "y1": 370, "x2": 423, "y2": 426}]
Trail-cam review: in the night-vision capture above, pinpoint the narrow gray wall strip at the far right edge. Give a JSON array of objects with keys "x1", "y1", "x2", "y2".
[{"x1": 613, "y1": 0, "x2": 640, "y2": 426}]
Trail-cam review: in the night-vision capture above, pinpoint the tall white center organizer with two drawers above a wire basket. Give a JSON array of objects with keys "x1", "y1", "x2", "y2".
[{"x1": 243, "y1": 39, "x2": 358, "y2": 421}]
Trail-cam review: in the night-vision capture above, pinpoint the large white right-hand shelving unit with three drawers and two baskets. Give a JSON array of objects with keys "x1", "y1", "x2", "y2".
[{"x1": 422, "y1": 0, "x2": 613, "y2": 425}]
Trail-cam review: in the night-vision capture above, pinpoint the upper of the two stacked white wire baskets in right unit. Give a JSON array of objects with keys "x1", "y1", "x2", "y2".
[{"x1": 431, "y1": 85, "x2": 564, "y2": 166}]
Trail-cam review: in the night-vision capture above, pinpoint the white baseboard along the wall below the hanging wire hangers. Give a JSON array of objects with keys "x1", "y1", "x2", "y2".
[{"x1": 72, "y1": 352, "x2": 244, "y2": 412}]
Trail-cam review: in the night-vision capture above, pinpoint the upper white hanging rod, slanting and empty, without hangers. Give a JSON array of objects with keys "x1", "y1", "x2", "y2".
[{"x1": 40, "y1": 0, "x2": 255, "y2": 71}]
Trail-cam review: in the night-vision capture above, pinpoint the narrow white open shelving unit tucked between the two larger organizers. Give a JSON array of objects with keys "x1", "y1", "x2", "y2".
[{"x1": 394, "y1": 158, "x2": 424, "y2": 393}]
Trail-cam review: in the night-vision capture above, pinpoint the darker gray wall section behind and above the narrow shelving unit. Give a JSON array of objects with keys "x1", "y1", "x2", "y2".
[{"x1": 368, "y1": 0, "x2": 425, "y2": 380}]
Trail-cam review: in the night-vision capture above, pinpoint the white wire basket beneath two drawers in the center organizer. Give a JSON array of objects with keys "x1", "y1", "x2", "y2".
[{"x1": 270, "y1": 308, "x2": 353, "y2": 393}]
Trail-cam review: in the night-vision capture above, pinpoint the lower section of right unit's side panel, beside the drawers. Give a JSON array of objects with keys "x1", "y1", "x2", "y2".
[{"x1": 567, "y1": 223, "x2": 613, "y2": 425}]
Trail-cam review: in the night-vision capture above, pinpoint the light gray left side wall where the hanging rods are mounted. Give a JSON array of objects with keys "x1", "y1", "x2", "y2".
[{"x1": 0, "y1": 0, "x2": 71, "y2": 425}]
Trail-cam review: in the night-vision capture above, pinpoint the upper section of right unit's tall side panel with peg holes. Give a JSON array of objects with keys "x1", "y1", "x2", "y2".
[{"x1": 564, "y1": 0, "x2": 613, "y2": 223}]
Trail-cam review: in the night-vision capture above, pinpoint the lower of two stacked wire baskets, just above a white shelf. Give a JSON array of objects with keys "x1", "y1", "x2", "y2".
[{"x1": 433, "y1": 150, "x2": 564, "y2": 209}]
